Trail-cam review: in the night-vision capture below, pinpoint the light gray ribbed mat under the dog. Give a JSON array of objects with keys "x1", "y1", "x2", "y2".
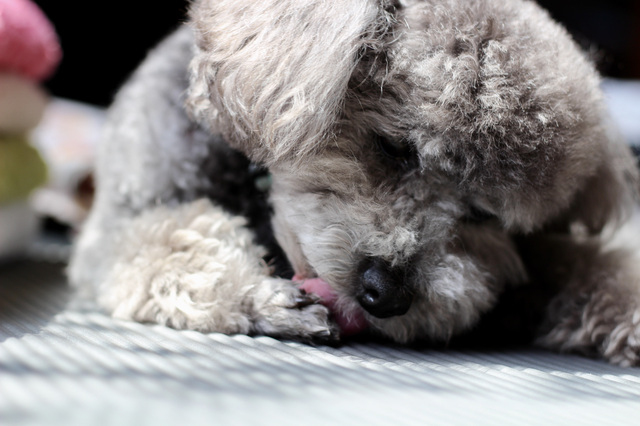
[{"x1": 0, "y1": 262, "x2": 640, "y2": 426}]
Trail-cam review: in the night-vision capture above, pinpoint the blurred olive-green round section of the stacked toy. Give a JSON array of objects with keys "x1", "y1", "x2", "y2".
[{"x1": 0, "y1": 136, "x2": 47, "y2": 206}]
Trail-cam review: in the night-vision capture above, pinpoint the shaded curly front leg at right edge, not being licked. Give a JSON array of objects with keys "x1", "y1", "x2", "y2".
[{"x1": 524, "y1": 228, "x2": 640, "y2": 366}]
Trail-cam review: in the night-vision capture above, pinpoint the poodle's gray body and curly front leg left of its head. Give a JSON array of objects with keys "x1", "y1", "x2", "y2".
[{"x1": 69, "y1": 28, "x2": 334, "y2": 340}]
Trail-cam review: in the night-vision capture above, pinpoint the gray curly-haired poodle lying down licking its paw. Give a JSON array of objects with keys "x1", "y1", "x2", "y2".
[{"x1": 69, "y1": 0, "x2": 640, "y2": 366}]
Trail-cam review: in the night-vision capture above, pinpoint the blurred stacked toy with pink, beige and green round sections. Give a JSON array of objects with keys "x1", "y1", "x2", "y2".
[{"x1": 0, "y1": 0, "x2": 61, "y2": 257}]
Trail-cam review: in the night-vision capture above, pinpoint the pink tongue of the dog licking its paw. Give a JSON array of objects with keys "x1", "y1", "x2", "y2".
[{"x1": 293, "y1": 275, "x2": 368, "y2": 336}]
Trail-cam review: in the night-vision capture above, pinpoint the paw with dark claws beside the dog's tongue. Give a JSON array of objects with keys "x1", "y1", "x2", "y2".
[{"x1": 253, "y1": 278, "x2": 339, "y2": 343}]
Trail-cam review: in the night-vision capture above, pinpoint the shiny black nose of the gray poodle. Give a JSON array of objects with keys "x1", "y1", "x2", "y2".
[{"x1": 356, "y1": 259, "x2": 413, "y2": 318}]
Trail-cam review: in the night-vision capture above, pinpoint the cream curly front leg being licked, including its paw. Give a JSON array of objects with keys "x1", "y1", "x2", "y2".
[{"x1": 84, "y1": 200, "x2": 332, "y2": 340}]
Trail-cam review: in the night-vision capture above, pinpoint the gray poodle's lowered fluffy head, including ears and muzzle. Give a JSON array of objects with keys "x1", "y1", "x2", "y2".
[{"x1": 189, "y1": 0, "x2": 631, "y2": 341}]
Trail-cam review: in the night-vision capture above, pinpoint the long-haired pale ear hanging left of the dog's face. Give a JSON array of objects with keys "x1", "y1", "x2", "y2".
[{"x1": 187, "y1": 0, "x2": 390, "y2": 165}]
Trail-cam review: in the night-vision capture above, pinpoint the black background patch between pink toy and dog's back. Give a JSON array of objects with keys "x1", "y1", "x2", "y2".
[{"x1": 35, "y1": 0, "x2": 189, "y2": 106}]
